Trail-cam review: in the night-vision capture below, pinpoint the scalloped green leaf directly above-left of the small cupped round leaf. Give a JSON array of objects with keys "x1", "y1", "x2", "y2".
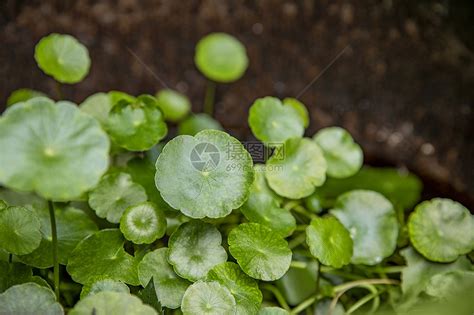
[{"x1": 89, "y1": 173, "x2": 147, "y2": 223}]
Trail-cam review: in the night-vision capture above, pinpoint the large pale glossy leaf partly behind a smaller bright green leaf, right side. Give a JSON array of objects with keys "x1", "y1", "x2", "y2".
[{"x1": 331, "y1": 190, "x2": 398, "y2": 265}]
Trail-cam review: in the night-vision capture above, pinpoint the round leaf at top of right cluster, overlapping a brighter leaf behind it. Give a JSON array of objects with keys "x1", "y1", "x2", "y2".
[{"x1": 248, "y1": 96, "x2": 304, "y2": 147}]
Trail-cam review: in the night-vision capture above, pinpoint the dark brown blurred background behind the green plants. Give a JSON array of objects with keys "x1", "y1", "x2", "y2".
[{"x1": 0, "y1": 0, "x2": 474, "y2": 211}]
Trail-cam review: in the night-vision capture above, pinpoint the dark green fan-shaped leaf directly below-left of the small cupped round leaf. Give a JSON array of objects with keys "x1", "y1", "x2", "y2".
[{"x1": 67, "y1": 229, "x2": 140, "y2": 285}]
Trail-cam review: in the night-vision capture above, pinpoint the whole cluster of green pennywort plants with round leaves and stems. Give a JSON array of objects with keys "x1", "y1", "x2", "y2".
[{"x1": 0, "y1": 33, "x2": 474, "y2": 315}]
